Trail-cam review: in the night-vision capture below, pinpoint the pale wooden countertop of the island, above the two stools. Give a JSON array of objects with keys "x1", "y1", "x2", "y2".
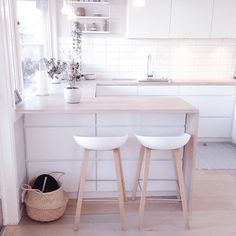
[{"x1": 16, "y1": 94, "x2": 198, "y2": 114}]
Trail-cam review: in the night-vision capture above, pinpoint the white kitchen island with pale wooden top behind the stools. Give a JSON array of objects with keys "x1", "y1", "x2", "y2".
[{"x1": 16, "y1": 92, "x2": 198, "y2": 207}]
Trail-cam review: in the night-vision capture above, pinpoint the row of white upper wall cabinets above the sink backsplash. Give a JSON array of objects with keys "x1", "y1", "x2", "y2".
[{"x1": 127, "y1": 0, "x2": 236, "y2": 38}]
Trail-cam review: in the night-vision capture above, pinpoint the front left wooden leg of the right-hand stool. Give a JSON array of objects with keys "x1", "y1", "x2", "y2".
[{"x1": 139, "y1": 148, "x2": 151, "y2": 229}]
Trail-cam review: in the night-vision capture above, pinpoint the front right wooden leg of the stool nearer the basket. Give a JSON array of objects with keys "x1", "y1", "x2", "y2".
[{"x1": 113, "y1": 149, "x2": 126, "y2": 230}]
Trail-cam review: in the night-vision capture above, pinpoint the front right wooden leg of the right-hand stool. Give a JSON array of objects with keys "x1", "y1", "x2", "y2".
[{"x1": 172, "y1": 149, "x2": 190, "y2": 229}]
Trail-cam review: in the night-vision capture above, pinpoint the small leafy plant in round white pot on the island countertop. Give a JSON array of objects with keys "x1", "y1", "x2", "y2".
[{"x1": 64, "y1": 61, "x2": 81, "y2": 104}]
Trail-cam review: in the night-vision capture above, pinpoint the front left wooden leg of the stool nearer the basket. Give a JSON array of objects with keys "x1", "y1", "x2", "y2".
[{"x1": 74, "y1": 149, "x2": 89, "y2": 230}]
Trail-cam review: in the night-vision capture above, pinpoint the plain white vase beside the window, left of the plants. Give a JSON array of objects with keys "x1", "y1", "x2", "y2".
[{"x1": 35, "y1": 71, "x2": 49, "y2": 96}]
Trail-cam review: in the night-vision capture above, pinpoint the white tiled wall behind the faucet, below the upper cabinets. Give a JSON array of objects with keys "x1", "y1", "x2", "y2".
[{"x1": 57, "y1": 0, "x2": 236, "y2": 80}]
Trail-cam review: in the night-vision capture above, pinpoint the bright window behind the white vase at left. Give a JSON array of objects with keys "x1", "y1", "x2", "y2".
[{"x1": 17, "y1": 0, "x2": 49, "y2": 95}]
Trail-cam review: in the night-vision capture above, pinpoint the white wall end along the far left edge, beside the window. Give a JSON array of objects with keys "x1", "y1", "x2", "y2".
[{"x1": 0, "y1": 0, "x2": 25, "y2": 225}]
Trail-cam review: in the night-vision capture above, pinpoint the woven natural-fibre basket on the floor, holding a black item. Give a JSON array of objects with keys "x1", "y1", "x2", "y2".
[{"x1": 22, "y1": 172, "x2": 69, "y2": 222}]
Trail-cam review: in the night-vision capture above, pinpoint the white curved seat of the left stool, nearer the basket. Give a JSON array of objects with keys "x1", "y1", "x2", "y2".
[{"x1": 74, "y1": 135, "x2": 128, "y2": 151}]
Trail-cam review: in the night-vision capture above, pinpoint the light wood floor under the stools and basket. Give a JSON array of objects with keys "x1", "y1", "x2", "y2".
[{"x1": 4, "y1": 171, "x2": 236, "y2": 236}]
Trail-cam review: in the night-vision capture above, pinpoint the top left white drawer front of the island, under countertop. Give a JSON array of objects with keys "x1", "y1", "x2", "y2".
[{"x1": 25, "y1": 114, "x2": 95, "y2": 126}]
